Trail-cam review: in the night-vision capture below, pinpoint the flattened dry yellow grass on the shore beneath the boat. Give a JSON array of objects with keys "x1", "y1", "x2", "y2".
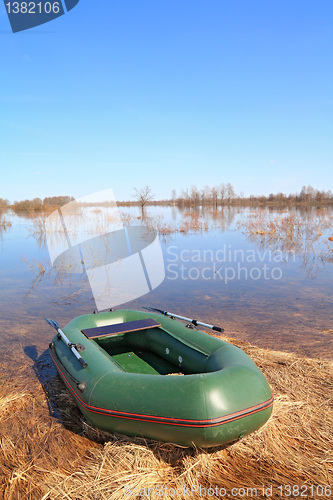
[{"x1": 0, "y1": 343, "x2": 333, "y2": 500}]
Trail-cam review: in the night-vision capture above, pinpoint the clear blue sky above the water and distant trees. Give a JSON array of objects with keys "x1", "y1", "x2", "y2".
[{"x1": 0, "y1": 0, "x2": 333, "y2": 201}]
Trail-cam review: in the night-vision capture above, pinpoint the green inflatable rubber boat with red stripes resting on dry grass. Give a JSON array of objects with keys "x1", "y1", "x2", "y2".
[{"x1": 47, "y1": 310, "x2": 273, "y2": 447}]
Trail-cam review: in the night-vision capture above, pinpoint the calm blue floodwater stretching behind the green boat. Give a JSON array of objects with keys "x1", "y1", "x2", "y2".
[{"x1": 0, "y1": 207, "x2": 333, "y2": 359}]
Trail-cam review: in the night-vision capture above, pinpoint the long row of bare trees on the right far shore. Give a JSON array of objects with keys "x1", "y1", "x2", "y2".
[{"x1": 171, "y1": 183, "x2": 333, "y2": 207}]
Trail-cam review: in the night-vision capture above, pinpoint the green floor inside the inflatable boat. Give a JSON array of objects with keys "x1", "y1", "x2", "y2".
[{"x1": 107, "y1": 349, "x2": 183, "y2": 375}]
